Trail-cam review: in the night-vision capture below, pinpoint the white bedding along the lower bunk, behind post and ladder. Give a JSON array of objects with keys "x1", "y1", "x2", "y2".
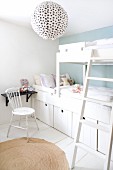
[{"x1": 34, "y1": 85, "x2": 113, "y2": 102}]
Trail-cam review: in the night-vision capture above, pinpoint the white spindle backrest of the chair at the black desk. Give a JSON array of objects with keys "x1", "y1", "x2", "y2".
[{"x1": 5, "y1": 87, "x2": 22, "y2": 110}]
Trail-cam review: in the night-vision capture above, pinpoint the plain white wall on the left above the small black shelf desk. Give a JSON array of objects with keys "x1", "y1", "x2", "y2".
[{"x1": 0, "y1": 21, "x2": 58, "y2": 124}]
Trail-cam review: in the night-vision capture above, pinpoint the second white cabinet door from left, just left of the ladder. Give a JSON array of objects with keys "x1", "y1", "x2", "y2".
[{"x1": 54, "y1": 107, "x2": 72, "y2": 136}]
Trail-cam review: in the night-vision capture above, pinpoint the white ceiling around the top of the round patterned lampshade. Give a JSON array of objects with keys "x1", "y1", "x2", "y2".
[{"x1": 0, "y1": 0, "x2": 113, "y2": 35}]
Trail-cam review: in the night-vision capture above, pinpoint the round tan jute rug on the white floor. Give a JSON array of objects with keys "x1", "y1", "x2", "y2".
[{"x1": 0, "y1": 138, "x2": 69, "y2": 170}]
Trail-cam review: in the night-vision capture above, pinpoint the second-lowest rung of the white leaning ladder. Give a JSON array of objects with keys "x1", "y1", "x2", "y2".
[{"x1": 80, "y1": 119, "x2": 110, "y2": 132}]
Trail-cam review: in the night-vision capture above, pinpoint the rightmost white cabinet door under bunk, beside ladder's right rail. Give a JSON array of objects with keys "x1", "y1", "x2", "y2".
[{"x1": 98, "y1": 122, "x2": 113, "y2": 160}]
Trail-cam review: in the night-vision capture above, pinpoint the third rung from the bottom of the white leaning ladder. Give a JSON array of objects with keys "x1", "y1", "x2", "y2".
[{"x1": 83, "y1": 97, "x2": 113, "y2": 106}]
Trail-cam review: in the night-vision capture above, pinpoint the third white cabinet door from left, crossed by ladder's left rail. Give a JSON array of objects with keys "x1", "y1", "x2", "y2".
[{"x1": 72, "y1": 113, "x2": 97, "y2": 150}]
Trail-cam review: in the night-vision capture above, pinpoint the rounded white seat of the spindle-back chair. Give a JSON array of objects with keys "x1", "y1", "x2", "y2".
[{"x1": 12, "y1": 107, "x2": 35, "y2": 115}]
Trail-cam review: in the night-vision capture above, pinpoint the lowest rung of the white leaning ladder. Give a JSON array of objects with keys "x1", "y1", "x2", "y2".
[{"x1": 75, "y1": 142, "x2": 106, "y2": 159}]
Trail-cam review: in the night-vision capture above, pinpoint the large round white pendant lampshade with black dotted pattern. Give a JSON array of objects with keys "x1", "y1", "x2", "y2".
[{"x1": 31, "y1": 1, "x2": 68, "y2": 40}]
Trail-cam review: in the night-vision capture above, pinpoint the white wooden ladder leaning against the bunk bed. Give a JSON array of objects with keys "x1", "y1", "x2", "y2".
[{"x1": 71, "y1": 57, "x2": 113, "y2": 170}]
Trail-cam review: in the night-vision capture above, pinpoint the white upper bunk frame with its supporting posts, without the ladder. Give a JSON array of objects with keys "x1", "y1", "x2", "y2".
[{"x1": 56, "y1": 46, "x2": 113, "y2": 96}]
